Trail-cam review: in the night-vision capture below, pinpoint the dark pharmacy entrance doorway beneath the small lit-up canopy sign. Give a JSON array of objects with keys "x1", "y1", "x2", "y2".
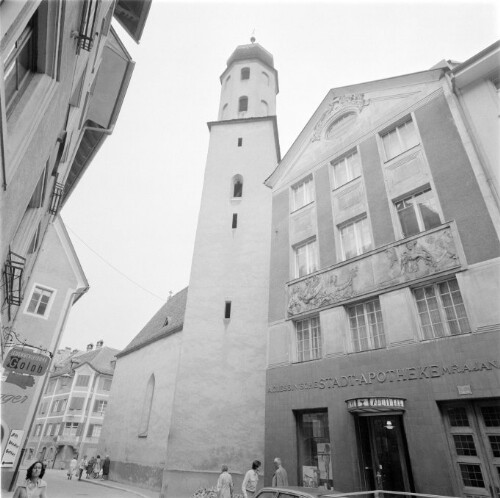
[{"x1": 358, "y1": 415, "x2": 413, "y2": 492}]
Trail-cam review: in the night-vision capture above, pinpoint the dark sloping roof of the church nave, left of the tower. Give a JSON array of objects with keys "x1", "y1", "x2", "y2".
[{"x1": 117, "y1": 287, "x2": 188, "y2": 358}]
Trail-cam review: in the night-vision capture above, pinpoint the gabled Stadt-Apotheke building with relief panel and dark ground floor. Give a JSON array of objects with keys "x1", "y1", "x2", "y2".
[{"x1": 265, "y1": 44, "x2": 500, "y2": 497}]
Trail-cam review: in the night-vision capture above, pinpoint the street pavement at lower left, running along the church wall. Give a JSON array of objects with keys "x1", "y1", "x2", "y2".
[{"x1": 1, "y1": 469, "x2": 160, "y2": 498}]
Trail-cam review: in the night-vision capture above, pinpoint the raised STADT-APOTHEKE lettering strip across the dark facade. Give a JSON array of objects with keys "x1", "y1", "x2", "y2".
[{"x1": 267, "y1": 360, "x2": 500, "y2": 393}]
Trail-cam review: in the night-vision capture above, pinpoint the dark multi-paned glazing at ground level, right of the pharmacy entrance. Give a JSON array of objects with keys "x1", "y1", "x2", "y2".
[{"x1": 441, "y1": 400, "x2": 500, "y2": 498}]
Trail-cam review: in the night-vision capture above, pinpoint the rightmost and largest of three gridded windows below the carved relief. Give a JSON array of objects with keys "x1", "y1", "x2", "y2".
[{"x1": 413, "y1": 278, "x2": 471, "y2": 339}]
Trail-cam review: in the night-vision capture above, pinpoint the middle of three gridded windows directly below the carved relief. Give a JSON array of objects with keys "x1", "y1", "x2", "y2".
[{"x1": 347, "y1": 298, "x2": 385, "y2": 352}]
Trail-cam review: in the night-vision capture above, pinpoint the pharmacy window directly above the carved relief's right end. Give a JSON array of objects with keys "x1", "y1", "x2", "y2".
[{"x1": 394, "y1": 188, "x2": 441, "y2": 237}]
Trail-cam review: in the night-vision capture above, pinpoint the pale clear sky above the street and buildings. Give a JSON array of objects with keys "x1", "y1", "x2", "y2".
[{"x1": 60, "y1": 0, "x2": 500, "y2": 350}]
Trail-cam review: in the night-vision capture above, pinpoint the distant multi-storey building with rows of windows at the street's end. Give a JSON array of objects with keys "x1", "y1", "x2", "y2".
[{"x1": 24, "y1": 341, "x2": 118, "y2": 469}]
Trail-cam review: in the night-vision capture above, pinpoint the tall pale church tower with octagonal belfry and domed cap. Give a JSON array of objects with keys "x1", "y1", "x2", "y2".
[{"x1": 161, "y1": 39, "x2": 280, "y2": 497}]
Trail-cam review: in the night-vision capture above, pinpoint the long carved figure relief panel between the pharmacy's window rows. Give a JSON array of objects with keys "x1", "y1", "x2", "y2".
[{"x1": 287, "y1": 226, "x2": 460, "y2": 316}]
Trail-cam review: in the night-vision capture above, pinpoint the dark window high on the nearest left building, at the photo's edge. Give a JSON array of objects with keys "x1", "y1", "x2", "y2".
[{"x1": 4, "y1": 19, "x2": 36, "y2": 113}]
